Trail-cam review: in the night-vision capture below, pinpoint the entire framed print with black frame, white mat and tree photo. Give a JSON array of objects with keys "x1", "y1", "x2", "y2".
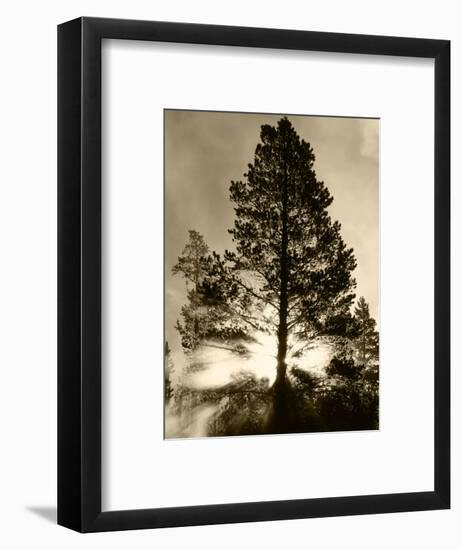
[{"x1": 58, "y1": 18, "x2": 450, "y2": 532}]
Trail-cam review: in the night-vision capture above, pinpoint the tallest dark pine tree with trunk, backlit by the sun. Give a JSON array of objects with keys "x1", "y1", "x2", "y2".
[{"x1": 202, "y1": 117, "x2": 356, "y2": 392}]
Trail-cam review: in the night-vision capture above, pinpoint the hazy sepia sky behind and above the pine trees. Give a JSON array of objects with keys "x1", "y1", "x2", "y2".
[{"x1": 165, "y1": 111, "x2": 379, "y2": 347}]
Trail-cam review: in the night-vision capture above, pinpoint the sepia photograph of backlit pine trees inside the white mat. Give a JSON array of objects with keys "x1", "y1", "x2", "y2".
[{"x1": 164, "y1": 109, "x2": 380, "y2": 439}]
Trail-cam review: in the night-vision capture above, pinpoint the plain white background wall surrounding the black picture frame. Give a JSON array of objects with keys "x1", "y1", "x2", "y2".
[{"x1": 0, "y1": 0, "x2": 461, "y2": 550}]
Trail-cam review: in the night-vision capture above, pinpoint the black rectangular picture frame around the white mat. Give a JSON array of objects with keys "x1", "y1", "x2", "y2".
[{"x1": 58, "y1": 17, "x2": 450, "y2": 532}]
